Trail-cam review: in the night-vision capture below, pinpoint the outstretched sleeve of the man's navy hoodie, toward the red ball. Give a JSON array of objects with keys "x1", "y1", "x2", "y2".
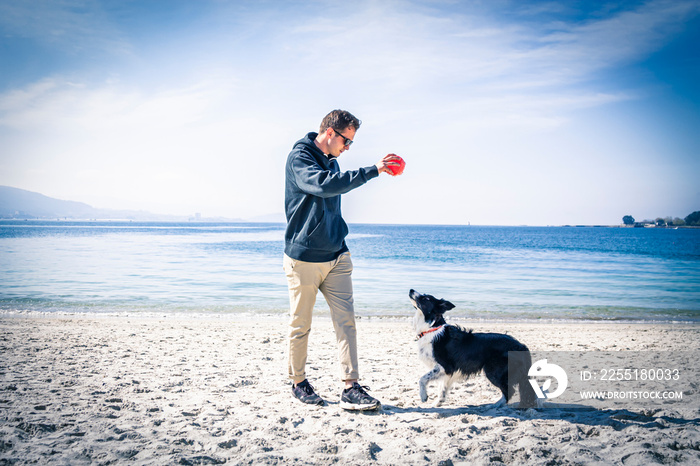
[{"x1": 291, "y1": 152, "x2": 379, "y2": 197}]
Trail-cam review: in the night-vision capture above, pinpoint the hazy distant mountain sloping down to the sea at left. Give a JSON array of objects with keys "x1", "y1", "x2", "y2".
[{"x1": 0, "y1": 186, "x2": 180, "y2": 221}]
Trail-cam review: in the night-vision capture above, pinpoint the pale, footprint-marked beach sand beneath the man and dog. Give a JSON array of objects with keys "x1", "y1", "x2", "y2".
[{"x1": 0, "y1": 316, "x2": 700, "y2": 465}]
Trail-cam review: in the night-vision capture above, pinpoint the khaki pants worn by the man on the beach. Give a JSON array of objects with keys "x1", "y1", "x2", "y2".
[{"x1": 284, "y1": 252, "x2": 359, "y2": 383}]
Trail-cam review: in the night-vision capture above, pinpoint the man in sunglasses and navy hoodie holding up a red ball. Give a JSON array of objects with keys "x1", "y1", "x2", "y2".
[{"x1": 284, "y1": 110, "x2": 399, "y2": 410}]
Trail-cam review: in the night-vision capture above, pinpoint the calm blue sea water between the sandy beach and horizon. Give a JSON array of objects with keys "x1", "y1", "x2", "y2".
[{"x1": 0, "y1": 221, "x2": 700, "y2": 322}]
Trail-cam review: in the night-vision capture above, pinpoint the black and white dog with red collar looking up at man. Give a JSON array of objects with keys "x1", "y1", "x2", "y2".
[{"x1": 408, "y1": 290, "x2": 536, "y2": 408}]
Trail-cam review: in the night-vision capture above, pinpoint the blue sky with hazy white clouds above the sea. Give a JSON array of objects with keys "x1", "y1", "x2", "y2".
[{"x1": 0, "y1": 0, "x2": 700, "y2": 225}]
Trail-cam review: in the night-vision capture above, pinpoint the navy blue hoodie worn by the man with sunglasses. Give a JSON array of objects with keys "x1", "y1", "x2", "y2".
[{"x1": 284, "y1": 133, "x2": 379, "y2": 262}]
